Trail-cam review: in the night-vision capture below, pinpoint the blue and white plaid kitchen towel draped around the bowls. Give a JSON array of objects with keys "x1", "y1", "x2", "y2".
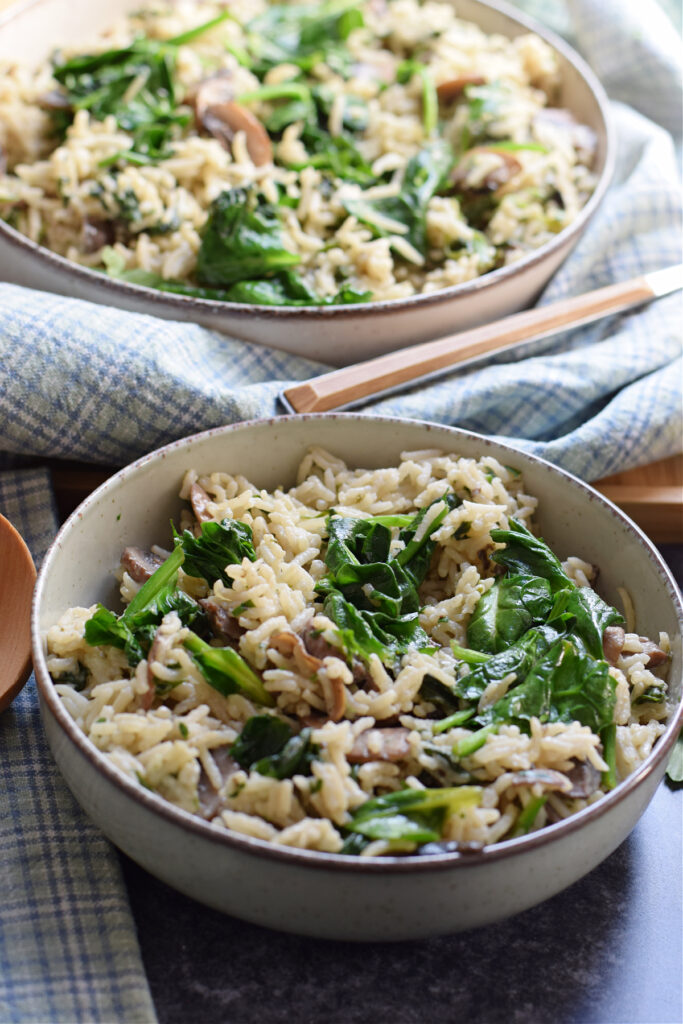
[{"x1": 0, "y1": 0, "x2": 683, "y2": 1022}]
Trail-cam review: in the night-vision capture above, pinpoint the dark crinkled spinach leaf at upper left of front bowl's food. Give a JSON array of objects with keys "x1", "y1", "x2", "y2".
[{"x1": 173, "y1": 519, "x2": 256, "y2": 587}]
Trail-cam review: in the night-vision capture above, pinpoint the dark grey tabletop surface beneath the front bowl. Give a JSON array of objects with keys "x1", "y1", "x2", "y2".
[{"x1": 121, "y1": 547, "x2": 683, "y2": 1024}]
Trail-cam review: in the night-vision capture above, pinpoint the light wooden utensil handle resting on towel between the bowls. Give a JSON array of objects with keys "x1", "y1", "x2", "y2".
[{"x1": 282, "y1": 270, "x2": 681, "y2": 413}]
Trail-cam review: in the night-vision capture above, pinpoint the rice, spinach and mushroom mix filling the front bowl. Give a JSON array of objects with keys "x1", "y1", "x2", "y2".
[{"x1": 47, "y1": 447, "x2": 670, "y2": 857}]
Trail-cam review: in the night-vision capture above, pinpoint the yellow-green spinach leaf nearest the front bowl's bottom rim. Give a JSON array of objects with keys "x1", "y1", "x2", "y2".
[{"x1": 346, "y1": 785, "x2": 481, "y2": 844}]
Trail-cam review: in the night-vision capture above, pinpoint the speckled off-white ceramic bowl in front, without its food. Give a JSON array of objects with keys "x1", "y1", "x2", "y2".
[{"x1": 33, "y1": 414, "x2": 683, "y2": 940}]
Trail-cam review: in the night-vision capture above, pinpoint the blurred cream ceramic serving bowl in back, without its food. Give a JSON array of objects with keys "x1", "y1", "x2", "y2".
[{"x1": 0, "y1": 0, "x2": 614, "y2": 366}]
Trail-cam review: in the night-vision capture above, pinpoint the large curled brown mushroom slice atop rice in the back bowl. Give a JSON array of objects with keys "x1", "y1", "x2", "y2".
[{"x1": 194, "y1": 73, "x2": 272, "y2": 167}]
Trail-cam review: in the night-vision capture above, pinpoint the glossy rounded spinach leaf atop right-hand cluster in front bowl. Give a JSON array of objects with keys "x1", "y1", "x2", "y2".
[{"x1": 467, "y1": 574, "x2": 553, "y2": 654}]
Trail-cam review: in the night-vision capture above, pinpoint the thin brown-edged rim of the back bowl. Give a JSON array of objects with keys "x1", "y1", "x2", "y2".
[{"x1": 0, "y1": 0, "x2": 616, "y2": 326}]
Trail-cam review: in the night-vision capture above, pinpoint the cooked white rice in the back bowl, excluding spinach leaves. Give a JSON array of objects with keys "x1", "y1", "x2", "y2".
[{"x1": 0, "y1": 0, "x2": 595, "y2": 301}]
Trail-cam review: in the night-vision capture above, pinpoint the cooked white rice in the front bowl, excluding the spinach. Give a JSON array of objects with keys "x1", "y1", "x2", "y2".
[{"x1": 47, "y1": 449, "x2": 669, "y2": 856}]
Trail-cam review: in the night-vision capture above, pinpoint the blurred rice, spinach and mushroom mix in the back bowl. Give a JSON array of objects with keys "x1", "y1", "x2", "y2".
[{"x1": 0, "y1": 0, "x2": 595, "y2": 306}]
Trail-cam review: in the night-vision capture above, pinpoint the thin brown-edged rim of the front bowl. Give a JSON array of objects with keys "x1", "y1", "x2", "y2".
[{"x1": 31, "y1": 413, "x2": 683, "y2": 874}]
